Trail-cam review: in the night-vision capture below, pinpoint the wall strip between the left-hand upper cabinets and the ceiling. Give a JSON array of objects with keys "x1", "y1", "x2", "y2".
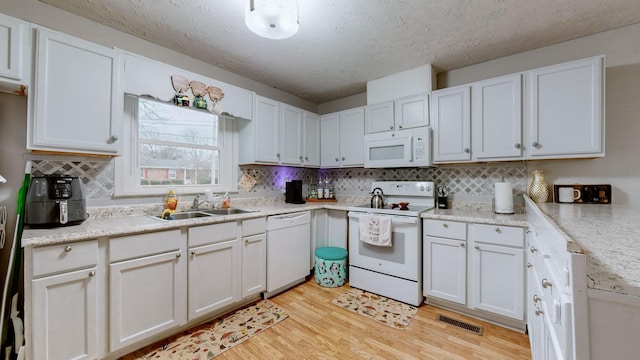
[{"x1": 0, "y1": 0, "x2": 317, "y2": 112}]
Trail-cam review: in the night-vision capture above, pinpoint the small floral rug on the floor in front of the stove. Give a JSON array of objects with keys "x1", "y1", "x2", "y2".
[{"x1": 333, "y1": 288, "x2": 418, "y2": 329}]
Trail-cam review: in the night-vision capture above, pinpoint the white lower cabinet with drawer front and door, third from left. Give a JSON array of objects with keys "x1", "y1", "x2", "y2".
[{"x1": 188, "y1": 221, "x2": 241, "y2": 320}]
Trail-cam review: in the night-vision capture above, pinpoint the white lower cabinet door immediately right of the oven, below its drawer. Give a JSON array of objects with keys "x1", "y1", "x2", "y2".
[{"x1": 423, "y1": 236, "x2": 467, "y2": 305}]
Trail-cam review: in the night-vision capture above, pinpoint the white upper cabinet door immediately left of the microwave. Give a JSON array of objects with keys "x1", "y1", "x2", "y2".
[{"x1": 340, "y1": 107, "x2": 364, "y2": 167}]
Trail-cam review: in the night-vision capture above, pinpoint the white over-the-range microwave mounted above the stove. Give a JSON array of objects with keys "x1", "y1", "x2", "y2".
[{"x1": 364, "y1": 127, "x2": 431, "y2": 168}]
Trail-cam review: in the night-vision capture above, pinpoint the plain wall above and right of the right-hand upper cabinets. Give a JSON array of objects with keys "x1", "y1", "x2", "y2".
[{"x1": 438, "y1": 24, "x2": 640, "y2": 204}]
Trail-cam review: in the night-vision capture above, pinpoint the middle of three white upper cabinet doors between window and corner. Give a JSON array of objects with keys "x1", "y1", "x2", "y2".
[{"x1": 280, "y1": 104, "x2": 304, "y2": 165}]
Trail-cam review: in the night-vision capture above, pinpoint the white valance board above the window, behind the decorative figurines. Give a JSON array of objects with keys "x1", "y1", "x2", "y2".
[{"x1": 122, "y1": 52, "x2": 254, "y2": 119}]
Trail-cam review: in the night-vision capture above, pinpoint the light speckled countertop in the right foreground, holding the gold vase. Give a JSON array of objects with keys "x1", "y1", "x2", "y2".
[{"x1": 536, "y1": 203, "x2": 640, "y2": 296}]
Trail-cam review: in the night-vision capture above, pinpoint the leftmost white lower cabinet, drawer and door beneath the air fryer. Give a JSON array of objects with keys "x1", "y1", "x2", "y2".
[{"x1": 25, "y1": 240, "x2": 100, "y2": 359}]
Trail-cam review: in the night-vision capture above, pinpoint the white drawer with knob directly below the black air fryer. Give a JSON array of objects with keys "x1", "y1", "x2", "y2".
[{"x1": 33, "y1": 240, "x2": 98, "y2": 277}]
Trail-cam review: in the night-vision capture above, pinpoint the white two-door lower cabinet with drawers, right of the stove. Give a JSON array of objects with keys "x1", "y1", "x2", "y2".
[{"x1": 423, "y1": 219, "x2": 525, "y2": 327}]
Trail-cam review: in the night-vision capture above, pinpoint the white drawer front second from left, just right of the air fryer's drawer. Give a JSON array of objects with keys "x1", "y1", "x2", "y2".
[{"x1": 109, "y1": 229, "x2": 184, "y2": 263}]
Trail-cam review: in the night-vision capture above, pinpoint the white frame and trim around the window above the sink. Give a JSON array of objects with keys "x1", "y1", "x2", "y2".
[{"x1": 113, "y1": 94, "x2": 238, "y2": 197}]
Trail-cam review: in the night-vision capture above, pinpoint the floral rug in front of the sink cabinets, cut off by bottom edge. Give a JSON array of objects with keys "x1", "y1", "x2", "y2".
[{"x1": 120, "y1": 300, "x2": 289, "y2": 360}]
